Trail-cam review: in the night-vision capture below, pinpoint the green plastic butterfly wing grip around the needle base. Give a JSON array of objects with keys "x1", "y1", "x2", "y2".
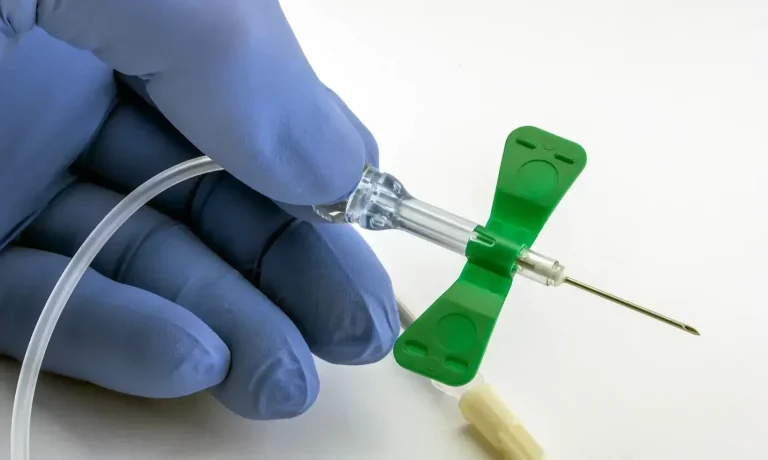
[{"x1": 394, "y1": 126, "x2": 587, "y2": 386}]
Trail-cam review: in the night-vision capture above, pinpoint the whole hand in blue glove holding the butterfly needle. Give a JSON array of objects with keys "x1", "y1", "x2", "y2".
[{"x1": 0, "y1": 0, "x2": 398, "y2": 419}]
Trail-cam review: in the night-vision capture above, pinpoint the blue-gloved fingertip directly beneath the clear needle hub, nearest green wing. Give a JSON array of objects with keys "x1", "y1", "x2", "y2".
[{"x1": 261, "y1": 222, "x2": 400, "y2": 365}]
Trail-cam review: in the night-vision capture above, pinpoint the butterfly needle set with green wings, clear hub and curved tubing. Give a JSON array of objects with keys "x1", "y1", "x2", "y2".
[{"x1": 10, "y1": 127, "x2": 699, "y2": 460}]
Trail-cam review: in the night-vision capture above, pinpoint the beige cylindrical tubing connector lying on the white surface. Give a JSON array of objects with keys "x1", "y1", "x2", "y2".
[{"x1": 459, "y1": 385, "x2": 544, "y2": 460}]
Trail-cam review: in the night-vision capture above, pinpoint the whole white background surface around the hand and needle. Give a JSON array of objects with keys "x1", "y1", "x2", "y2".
[{"x1": 0, "y1": 0, "x2": 768, "y2": 460}]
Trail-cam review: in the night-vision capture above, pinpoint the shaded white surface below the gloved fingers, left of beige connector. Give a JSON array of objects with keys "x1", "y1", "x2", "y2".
[{"x1": 0, "y1": 359, "x2": 493, "y2": 460}]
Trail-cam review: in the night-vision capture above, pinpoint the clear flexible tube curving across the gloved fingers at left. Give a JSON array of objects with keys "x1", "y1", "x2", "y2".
[{"x1": 11, "y1": 156, "x2": 222, "y2": 460}]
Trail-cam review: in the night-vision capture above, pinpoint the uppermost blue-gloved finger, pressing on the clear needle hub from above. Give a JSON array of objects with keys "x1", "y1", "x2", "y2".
[{"x1": 16, "y1": 0, "x2": 374, "y2": 205}]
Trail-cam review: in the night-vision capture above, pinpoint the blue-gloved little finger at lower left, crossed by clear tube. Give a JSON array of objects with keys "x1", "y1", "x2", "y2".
[{"x1": 0, "y1": 247, "x2": 230, "y2": 398}]
